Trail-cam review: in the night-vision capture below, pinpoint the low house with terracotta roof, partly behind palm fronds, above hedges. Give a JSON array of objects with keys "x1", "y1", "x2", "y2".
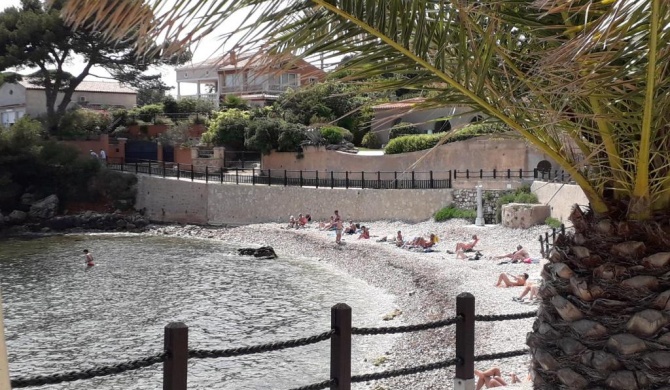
[{"x1": 371, "y1": 98, "x2": 483, "y2": 144}]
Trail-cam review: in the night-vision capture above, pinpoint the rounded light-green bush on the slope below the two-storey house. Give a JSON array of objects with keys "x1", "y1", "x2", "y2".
[{"x1": 202, "y1": 109, "x2": 251, "y2": 150}]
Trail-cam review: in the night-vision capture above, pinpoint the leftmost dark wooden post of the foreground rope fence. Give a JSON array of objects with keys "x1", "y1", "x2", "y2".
[{"x1": 163, "y1": 322, "x2": 188, "y2": 390}]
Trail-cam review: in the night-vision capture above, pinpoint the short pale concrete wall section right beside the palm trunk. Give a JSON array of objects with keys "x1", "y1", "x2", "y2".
[{"x1": 530, "y1": 181, "x2": 589, "y2": 223}]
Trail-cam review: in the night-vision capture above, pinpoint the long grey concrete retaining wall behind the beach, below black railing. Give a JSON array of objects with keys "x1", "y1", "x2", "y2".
[{"x1": 136, "y1": 175, "x2": 452, "y2": 224}]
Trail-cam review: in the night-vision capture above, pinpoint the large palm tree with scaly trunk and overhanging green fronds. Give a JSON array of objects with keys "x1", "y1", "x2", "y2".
[{"x1": 59, "y1": 0, "x2": 670, "y2": 389}]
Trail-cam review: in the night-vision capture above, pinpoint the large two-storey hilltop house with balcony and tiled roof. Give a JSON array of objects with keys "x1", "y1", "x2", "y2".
[{"x1": 176, "y1": 51, "x2": 326, "y2": 107}]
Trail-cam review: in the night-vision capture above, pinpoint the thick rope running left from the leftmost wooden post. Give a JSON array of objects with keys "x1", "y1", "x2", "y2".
[{"x1": 11, "y1": 352, "x2": 167, "y2": 389}]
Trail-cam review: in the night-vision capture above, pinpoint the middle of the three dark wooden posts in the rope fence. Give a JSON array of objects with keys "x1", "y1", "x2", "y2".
[{"x1": 330, "y1": 303, "x2": 351, "y2": 390}]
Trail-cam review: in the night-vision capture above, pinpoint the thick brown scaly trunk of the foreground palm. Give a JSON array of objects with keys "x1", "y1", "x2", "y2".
[{"x1": 527, "y1": 206, "x2": 670, "y2": 390}]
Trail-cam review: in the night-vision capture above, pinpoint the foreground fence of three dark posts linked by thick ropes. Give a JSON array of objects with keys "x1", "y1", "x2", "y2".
[{"x1": 11, "y1": 293, "x2": 537, "y2": 390}]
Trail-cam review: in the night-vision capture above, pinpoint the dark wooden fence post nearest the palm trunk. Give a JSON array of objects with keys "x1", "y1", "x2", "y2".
[{"x1": 454, "y1": 293, "x2": 475, "y2": 390}]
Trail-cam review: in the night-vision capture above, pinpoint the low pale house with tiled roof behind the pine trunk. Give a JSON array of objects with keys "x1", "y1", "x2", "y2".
[{"x1": 0, "y1": 81, "x2": 137, "y2": 125}]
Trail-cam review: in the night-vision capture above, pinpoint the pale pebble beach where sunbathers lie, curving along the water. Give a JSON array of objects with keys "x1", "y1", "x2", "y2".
[{"x1": 150, "y1": 215, "x2": 549, "y2": 390}]
